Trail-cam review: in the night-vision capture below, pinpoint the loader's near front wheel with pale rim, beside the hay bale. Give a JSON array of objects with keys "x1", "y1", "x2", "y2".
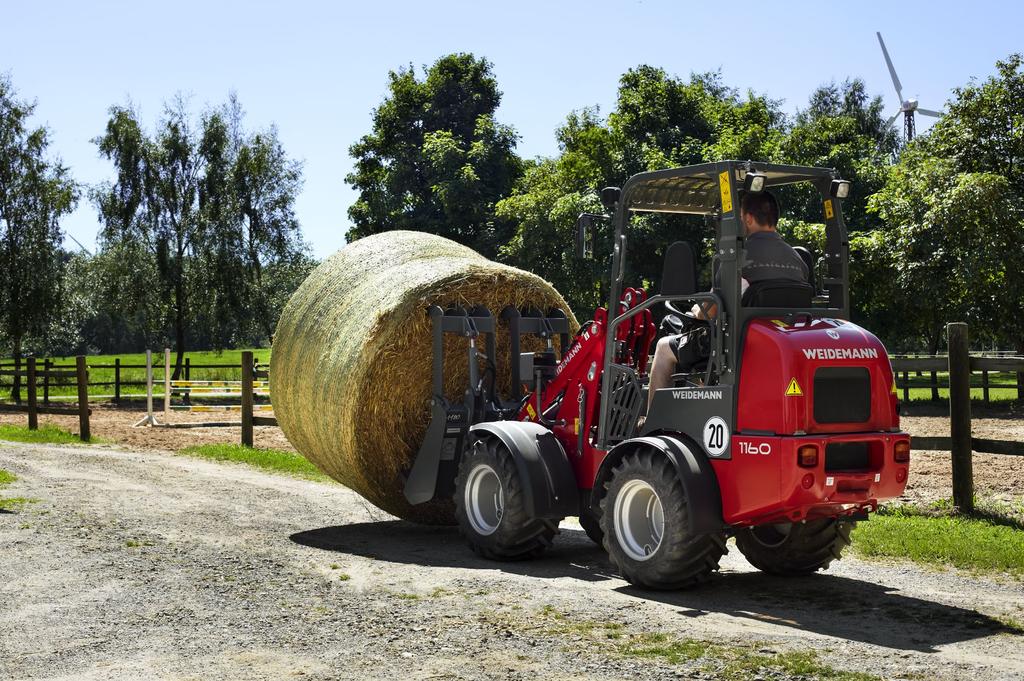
[{"x1": 455, "y1": 437, "x2": 559, "y2": 560}]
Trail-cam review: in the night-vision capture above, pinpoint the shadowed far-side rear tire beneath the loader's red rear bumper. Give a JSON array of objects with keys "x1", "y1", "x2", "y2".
[{"x1": 736, "y1": 518, "x2": 857, "y2": 577}]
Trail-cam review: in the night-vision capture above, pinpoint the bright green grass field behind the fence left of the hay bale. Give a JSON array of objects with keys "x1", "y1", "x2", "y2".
[{"x1": 0, "y1": 348, "x2": 270, "y2": 401}]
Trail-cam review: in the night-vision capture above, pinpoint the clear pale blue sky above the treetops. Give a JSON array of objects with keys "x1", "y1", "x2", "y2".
[{"x1": 0, "y1": 0, "x2": 1024, "y2": 257}]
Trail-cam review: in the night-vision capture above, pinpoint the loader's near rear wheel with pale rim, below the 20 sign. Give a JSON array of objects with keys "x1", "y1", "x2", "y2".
[{"x1": 601, "y1": 450, "x2": 726, "y2": 589}]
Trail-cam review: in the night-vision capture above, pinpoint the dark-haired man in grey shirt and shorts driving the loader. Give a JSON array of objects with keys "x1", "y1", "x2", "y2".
[{"x1": 647, "y1": 191, "x2": 809, "y2": 411}]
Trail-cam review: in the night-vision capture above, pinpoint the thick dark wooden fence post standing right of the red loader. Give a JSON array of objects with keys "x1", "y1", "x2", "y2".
[{"x1": 946, "y1": 322, "x2": 974, "y2": 513}]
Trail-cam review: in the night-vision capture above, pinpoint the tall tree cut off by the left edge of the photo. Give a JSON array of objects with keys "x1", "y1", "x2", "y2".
[{"x1": 0, "y1": 76, "x2": 78, "y2": 400}]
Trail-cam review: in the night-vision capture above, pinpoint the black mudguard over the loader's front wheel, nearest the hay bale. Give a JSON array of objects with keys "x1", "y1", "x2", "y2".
[{"x1": 470, "y1": 421, "x2": 580, "y2": 518}]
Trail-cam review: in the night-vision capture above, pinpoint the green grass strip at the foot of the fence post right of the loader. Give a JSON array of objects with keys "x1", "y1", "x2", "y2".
[{"x1": 853, "y1": 506, "x2": 1024, "y2": 580}]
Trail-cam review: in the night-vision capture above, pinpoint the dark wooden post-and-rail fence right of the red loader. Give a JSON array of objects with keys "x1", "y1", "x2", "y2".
[{"x1": 892, "y1": 322, "x2": 1024, "y2": 511}]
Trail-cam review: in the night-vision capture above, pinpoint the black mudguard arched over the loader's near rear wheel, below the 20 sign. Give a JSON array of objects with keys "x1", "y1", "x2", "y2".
[{"x1": 591, "y1": 435, "x2": 725, "y2": 535}]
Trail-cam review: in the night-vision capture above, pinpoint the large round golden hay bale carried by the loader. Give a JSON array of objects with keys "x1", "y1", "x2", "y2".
[{"x1": 270, "y1": 231, "x2": 575, "y2": 523}]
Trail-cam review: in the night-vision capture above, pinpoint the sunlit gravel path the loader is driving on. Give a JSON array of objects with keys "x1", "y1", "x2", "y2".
[{"x1": 0, "y1": 444, "x2": 1024, "y2": 681}]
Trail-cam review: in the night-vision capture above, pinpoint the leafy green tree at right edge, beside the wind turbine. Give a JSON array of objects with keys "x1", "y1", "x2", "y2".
[{"x1": 869, "y1": 54, "x2": 1024, "y2": 352}]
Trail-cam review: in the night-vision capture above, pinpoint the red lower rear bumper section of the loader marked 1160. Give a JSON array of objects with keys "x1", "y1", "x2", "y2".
[{"x1": 712, "y1": 432, "x2": 910, "y2": 526}]
